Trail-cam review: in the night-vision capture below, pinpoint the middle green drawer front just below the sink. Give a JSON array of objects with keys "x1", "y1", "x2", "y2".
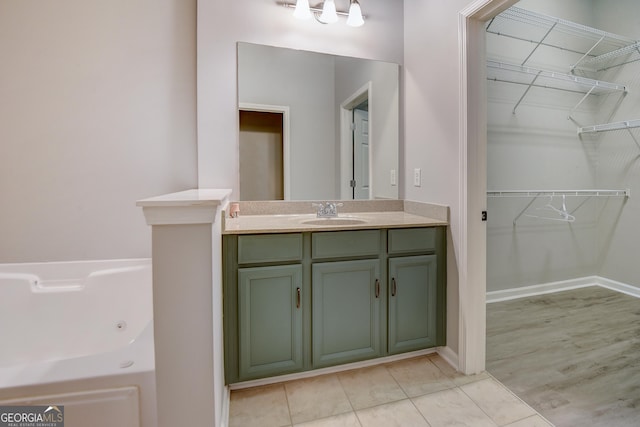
[{"x1": 311, "y1": 230, "x2": 380, "y2": 259}]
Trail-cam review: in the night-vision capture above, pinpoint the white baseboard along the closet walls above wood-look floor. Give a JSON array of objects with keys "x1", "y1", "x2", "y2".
[{"x1": 487, "y1": 276, "x2": 640, "y2": 304}]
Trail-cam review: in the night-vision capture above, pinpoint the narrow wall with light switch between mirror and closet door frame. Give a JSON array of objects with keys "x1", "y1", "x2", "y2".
[{"x1": 401, "y1": 0, "x2": 482, "y2": 360}]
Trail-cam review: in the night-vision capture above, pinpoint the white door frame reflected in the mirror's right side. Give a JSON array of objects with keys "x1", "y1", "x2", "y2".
[{"x1": 340, "y1": 81, "x2": 373, "y2": 200}]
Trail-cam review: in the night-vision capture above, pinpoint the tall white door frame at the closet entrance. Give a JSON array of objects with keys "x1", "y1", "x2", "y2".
[{"x1": 458, "y1": 0, "x2": 517, "y2": 375}]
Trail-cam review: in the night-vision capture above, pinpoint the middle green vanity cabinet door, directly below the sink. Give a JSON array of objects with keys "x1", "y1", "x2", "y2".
[{"x1": 312, "y1": 259, "x2": 382, "y2": 368}]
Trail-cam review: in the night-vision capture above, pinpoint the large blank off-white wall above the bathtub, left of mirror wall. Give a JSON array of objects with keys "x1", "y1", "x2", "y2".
[{"x1": 0, "y1": 0, "x2": 196, "y2": 262}]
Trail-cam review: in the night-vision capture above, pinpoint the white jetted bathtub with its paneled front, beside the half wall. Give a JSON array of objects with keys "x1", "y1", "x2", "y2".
[{"x1": 0, "y1": 259, "x2": 157, "y2": 427}]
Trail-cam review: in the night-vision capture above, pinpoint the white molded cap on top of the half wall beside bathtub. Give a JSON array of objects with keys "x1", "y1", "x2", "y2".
[{"x1": 136, "y1": 188, "x2": 231, "y2": 225}]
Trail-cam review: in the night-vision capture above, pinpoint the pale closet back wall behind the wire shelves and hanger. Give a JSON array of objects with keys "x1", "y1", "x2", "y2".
[{"x1": 487, "y1": 0, "x2": 599, "y2": 291}]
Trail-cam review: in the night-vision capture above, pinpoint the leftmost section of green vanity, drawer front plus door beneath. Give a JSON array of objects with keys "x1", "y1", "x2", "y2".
[{"x1": 222, "y1": 233, "x2": 308, "y2": 383}]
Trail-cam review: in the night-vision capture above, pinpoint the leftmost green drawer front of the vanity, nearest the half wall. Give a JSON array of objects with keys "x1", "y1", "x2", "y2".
[{"x1": 238, "y1": 233, "x2": 302, "y2": 264}]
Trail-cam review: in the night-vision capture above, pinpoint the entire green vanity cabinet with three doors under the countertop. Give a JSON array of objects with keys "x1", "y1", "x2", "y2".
[{"x1": 222, "y1": 226, "x2": 446, "y2": 384}]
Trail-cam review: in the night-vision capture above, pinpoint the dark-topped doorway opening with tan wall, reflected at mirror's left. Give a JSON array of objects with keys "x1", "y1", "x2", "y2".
[{"x1": 240, "y1": 110, "x2": 284, "y2": 200}]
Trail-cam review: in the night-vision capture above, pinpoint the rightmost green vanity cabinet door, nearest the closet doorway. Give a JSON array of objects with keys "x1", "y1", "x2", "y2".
[{"x1": 388, "y1": 255, "x2": 438, "y2": 354}]
